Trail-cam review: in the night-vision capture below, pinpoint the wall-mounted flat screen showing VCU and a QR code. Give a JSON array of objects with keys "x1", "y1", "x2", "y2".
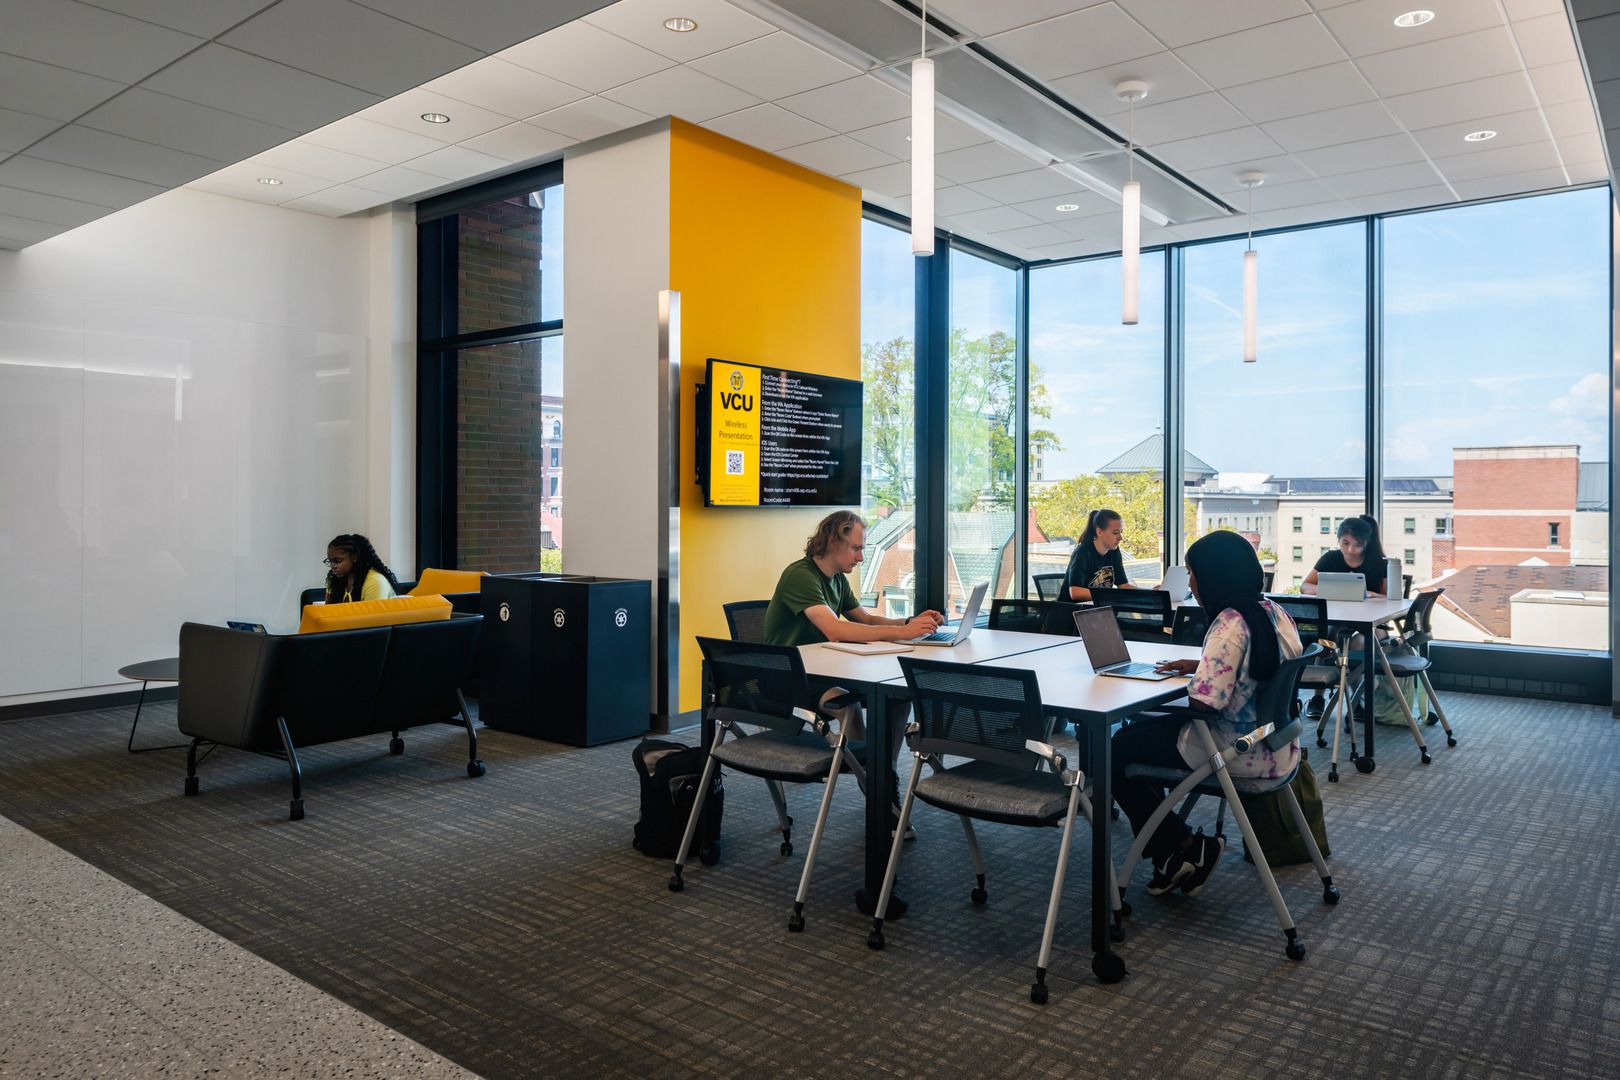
[{"x1": 697, "y1": 358, "x2": 862, "y2": 507}]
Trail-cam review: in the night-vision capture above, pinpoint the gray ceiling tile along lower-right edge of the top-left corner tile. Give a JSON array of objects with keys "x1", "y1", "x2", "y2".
[{"x1": 141, "y1": 44, "x2": 377, "y2": 131}]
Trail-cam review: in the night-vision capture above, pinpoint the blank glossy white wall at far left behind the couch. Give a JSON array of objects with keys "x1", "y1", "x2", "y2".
[{"x1": 0, "y1": 189, "x2": 375, "y2": 704}]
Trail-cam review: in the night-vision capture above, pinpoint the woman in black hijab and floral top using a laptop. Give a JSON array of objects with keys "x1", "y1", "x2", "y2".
[{"x1": 1113, "y1": 531, "x2": 1301, "y2": 895}]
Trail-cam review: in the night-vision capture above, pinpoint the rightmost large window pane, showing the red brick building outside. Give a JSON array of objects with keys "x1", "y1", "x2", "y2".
[{"x1": 1383, "y1": 188, "x2": 1612, "y2": 649}]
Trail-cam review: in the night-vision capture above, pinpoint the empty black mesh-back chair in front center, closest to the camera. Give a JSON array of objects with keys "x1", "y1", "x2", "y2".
[{"x1": 867, "y1": 656, "x2": 1118, "y2": 1004}]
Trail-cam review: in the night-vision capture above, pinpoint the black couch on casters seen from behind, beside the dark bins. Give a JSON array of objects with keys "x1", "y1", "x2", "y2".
[{"x1": 178, "y1": 614, "x2": 484, "y2": 821}]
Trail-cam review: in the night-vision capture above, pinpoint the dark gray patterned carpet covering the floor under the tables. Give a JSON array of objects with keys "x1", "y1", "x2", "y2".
[{"x1": 0, "y1": 693, "x2": 1620, "y2": 1078}]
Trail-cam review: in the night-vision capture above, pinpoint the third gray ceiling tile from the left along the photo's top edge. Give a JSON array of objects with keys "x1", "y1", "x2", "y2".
[{"x1": 219, "y1": 0, "x2": 480, "y2": 97}]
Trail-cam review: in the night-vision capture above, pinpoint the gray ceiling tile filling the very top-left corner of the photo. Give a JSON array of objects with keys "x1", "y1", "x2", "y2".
[{"x1": 0, "y1": 0, "x2": 203, "y2": 83}]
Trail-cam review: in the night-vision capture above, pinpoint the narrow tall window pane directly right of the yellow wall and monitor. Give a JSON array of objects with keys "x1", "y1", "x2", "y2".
[{"x1": 855, "y1": 219, "x2": 917, "y2": 615}]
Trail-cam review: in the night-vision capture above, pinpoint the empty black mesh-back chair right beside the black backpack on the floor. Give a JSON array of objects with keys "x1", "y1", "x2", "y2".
[{"x1": 669, "y1": 638, "x2": 865, "y2": 931}]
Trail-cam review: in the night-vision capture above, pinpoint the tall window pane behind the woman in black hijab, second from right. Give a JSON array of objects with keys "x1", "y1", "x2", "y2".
[{"x1": 1183, "y1": 222, "x2": 1367, "y2": 589}]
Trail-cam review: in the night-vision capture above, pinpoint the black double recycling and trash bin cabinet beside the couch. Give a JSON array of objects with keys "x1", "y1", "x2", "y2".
[{"x1": 478, "y1": 573, "x2": 653, "y2": 746}]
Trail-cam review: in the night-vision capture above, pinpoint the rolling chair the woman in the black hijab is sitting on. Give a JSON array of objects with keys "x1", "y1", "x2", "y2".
[{"x1": 1119, "y1": 643, "x2": 1340, "y2": 960}]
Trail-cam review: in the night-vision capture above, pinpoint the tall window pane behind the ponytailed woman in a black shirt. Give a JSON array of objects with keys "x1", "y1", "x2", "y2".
[{"x1": 1029, "y1": 251, "x2": 1165, "y2": 596}]
